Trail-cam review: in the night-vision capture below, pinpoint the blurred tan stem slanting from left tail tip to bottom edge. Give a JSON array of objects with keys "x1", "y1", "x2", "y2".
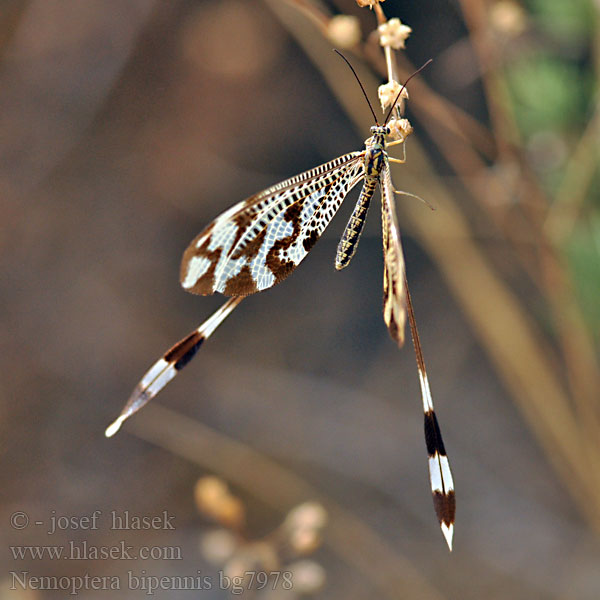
[{"x1": 127, "y1": 404, "x2": 444, "y2": 600}]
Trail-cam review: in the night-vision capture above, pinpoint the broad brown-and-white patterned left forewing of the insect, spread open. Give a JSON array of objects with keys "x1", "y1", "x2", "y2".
[{"x1": 181, "y1": 152, "x2": 364, "y2": 296}]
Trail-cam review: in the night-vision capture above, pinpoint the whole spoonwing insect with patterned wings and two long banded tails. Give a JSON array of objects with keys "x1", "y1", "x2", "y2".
[{"x1": 106, "y1": 56, "x2": 455, "y2": 550}]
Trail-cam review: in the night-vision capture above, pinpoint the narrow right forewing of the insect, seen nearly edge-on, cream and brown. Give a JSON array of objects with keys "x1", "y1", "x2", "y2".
[{"x1": 381, "y1": 164, "x2": 406, "y2": 346}]
